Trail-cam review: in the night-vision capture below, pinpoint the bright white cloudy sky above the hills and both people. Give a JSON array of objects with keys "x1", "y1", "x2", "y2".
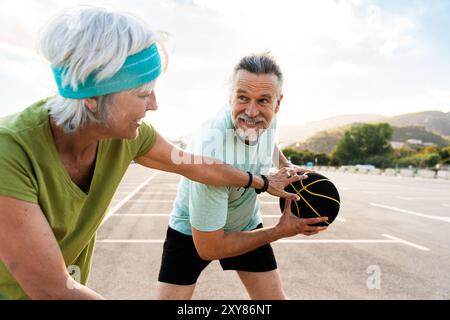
[{"x1": 0, "y1": 0, "x2": 450, "y2": 139}]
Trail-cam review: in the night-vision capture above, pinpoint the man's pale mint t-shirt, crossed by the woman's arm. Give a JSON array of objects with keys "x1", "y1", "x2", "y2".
[{"x1": 169, "y1": 106, "x2": 276, "y2": 235}]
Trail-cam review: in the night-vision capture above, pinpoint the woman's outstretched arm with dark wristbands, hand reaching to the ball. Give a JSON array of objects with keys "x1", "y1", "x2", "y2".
[{"x1": 135, "y1": 134, "x2": 303, "y2": 200}]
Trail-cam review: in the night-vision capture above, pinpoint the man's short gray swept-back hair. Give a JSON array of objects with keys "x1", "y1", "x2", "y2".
[{"x1": 232, "y1": 51, "x2": 284, "y2": 93}]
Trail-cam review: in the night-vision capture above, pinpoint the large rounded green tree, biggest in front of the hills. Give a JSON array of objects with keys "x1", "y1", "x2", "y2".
[{"x1": 333, "y1": 123, "x2": 394, "y2": 165}]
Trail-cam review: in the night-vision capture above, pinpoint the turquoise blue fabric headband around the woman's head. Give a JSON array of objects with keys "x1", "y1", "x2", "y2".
[{"x1": 52, "y1": 44, "x2": 161, "y2": 99}]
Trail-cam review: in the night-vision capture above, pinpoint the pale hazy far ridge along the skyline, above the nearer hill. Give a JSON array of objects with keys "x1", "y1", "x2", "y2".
[{"x1": 279, "y1": 111, "x2": 450, "y2": 147}]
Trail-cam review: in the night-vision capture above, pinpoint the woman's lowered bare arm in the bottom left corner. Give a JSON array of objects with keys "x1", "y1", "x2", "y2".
[{"x1": 0, "y1": 195, "x2": 103, "y2": 300}]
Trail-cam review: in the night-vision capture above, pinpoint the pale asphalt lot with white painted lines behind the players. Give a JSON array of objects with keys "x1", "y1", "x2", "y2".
[{"x1": 89, "y1": 164, "x2": 450, "y2": 300}]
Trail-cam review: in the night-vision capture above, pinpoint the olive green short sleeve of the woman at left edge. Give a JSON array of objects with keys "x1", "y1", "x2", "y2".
[{"x1": 0, "y1": 134, "x2": 38, "y2": 203}]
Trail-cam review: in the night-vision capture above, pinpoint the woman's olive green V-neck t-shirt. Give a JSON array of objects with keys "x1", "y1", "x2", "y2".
[{"x1": 0, "y1": 100, "x2": 156, "y2": 299}]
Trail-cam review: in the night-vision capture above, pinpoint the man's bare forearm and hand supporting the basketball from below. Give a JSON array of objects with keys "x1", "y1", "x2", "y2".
[{"x1": 192, "y1": 200, "x2": 328, "y2": 260}]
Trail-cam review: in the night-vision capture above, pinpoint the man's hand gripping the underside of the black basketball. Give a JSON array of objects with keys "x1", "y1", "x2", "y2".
[{"x1": 276, "y1": 199, "x2": 328, "y2": 238}]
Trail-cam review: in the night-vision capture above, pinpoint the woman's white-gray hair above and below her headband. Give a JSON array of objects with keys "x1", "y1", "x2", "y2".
[{"x1": 39, "y1": 6, "x2": 168, "y2": 133}]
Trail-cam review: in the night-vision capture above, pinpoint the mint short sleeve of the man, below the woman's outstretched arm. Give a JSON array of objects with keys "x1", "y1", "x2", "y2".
[{"x1": 189, "y1": 181, "x2": 228, "y2": 232}]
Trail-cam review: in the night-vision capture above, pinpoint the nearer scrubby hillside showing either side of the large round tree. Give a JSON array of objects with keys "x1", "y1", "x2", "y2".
[{"x1": 291, "y1": 125, "x2": 449, "y2": 153}]
